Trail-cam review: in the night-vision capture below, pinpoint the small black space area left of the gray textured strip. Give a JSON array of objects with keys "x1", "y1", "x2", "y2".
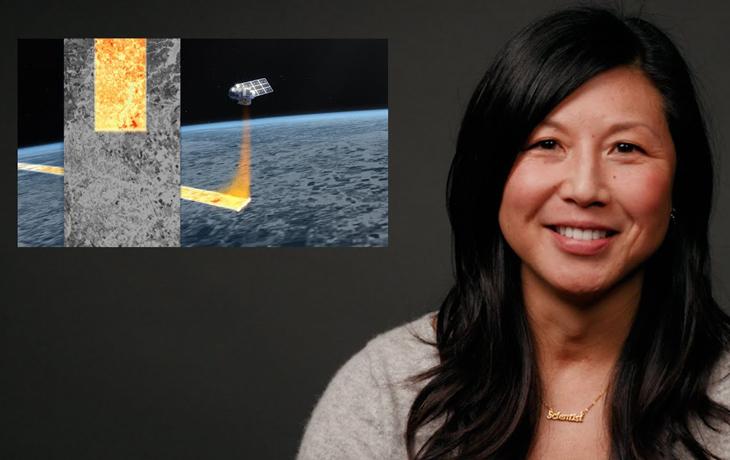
[{"x1": 18, "y1": 39, "x2": 63, "y2": 147}]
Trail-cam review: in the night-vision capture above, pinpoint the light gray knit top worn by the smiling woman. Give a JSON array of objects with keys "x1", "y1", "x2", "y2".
[{"x1": 297, "y1": 313, "x2": 730, "y2": 460}]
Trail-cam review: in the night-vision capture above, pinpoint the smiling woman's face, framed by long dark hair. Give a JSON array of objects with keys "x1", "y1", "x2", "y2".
[{"x1": 499, "y1": 67, "x2": 676, "y2": 296}]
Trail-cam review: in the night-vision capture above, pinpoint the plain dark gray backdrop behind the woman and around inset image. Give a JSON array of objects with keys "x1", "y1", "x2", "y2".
[{"x1": 0, "y1": 0, "x2": 730, "y2": 459}]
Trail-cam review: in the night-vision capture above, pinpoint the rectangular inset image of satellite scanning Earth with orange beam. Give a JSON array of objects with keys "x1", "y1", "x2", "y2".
[{"x1": 17, "y1": 38, "x2": 388, "y2": 247}]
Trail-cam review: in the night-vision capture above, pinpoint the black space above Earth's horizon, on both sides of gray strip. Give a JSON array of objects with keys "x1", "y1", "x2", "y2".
[{"x1": 18, "y1": 39, "x2": 388, "y2": 147}]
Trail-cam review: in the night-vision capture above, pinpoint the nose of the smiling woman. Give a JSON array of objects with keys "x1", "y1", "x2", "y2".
[{"x1": 558, "y1": 149, "x2": 610, "y2": 207}]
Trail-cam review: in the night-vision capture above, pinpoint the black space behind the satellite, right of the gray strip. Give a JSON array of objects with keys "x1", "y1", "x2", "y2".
[{"x1": 180, "y1": 39, "x2": 388, "y2": 125}]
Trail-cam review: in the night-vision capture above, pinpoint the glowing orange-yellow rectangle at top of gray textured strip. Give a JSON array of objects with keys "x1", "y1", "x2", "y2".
[{"x1": 94, "y1": 38, "x2": 147, "y2": 131}]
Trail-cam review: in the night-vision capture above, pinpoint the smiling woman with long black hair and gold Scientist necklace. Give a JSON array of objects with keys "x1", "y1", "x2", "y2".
[{"x1": 299, "y1": 9, "x2": 730, "y2": 459}]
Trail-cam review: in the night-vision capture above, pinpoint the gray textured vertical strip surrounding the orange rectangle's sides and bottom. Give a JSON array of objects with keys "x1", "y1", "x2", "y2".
[{"x1": 64, "y1": 39, "x2": 180, "y2": 246}]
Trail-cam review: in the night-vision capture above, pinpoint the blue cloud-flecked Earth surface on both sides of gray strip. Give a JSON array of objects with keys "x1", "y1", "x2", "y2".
[{"x1": 18, "y1": 110, "x2": 388, "y2": 247}]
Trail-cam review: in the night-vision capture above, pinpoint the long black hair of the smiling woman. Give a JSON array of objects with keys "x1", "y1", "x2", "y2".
[{"x1": 406, "y1": 8, "x2": 730, "y2": 460}]
